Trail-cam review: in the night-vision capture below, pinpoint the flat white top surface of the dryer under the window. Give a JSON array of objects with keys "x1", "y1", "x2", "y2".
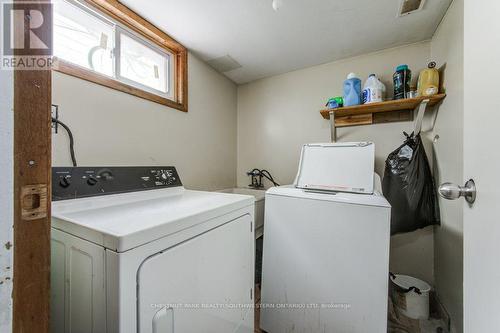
[{"x1": 52, "y1": 187, "x2": 254, "y2": 252}]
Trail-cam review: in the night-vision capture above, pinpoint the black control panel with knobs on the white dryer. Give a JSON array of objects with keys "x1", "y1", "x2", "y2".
[{"x1": 52, "y1": 166, "x2": 182, "y2": 201}]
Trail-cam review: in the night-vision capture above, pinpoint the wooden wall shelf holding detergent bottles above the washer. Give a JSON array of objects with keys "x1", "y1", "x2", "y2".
[{"x1": 320, "y1": 94, "x2": 446, "y2": 127}]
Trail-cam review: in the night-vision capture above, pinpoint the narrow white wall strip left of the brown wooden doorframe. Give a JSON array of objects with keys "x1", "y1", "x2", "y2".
[{"x1": 0, "y1": 65, "x2": 14, "y2": 332}]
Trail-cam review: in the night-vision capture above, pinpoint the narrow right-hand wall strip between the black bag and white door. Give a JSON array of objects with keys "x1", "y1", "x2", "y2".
[{"x1": 431, "y1": 0, "x2": 464, "y2": 332}]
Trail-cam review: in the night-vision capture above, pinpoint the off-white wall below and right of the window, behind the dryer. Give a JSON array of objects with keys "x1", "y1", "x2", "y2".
[{"x1": 52, "y1": 54, "x2": 237, "y2": 190}]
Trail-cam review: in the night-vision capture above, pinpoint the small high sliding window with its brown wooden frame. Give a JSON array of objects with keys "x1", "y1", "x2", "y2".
[{"x1": 54, "y1": 0, "x2": 187, "y2": 111}]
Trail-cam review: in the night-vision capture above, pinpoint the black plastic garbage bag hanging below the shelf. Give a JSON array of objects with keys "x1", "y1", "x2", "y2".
[{"x1": 382, "y1": 133, "x2": 440, "y2": 235}]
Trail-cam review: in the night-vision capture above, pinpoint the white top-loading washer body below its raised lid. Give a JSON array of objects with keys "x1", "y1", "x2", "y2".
[{"x1": 261, "y1": 178, "x2": 390, "y2": 333}]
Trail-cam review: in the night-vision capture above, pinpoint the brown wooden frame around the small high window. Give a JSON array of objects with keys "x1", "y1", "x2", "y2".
[{"x1": 52, "y1": 0, "x2": 188, "y2": 112}]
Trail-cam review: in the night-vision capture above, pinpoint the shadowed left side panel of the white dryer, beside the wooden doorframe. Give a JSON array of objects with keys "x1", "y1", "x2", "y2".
[{"x1": 50, "y1": 228, "x2": 106, "y2": 333}]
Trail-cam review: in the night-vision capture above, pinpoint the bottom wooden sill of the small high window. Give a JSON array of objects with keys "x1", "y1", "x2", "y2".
[{"x1": 52, "y1": 58, "x2": 188, "y2": 112}]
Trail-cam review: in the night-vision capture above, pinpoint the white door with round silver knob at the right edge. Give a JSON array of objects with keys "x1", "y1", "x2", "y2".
[{"x1": 461, "y1": 0, "x2": 500, "y2": 333}]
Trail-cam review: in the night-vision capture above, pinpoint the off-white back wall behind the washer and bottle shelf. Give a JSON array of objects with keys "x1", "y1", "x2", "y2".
[{"x1": 237, "y1": 42, "x2": 433, "y2": 283}]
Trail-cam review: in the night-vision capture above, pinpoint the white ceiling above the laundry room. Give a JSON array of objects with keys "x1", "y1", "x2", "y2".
[{"x1": 121, "y1": 0, "x2": 452, "y2": 84}]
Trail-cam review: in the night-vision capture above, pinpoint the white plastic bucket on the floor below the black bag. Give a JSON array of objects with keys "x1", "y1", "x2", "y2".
[{"x1": 390, "y1": 274, "x2": 431, "y2": 319}]
